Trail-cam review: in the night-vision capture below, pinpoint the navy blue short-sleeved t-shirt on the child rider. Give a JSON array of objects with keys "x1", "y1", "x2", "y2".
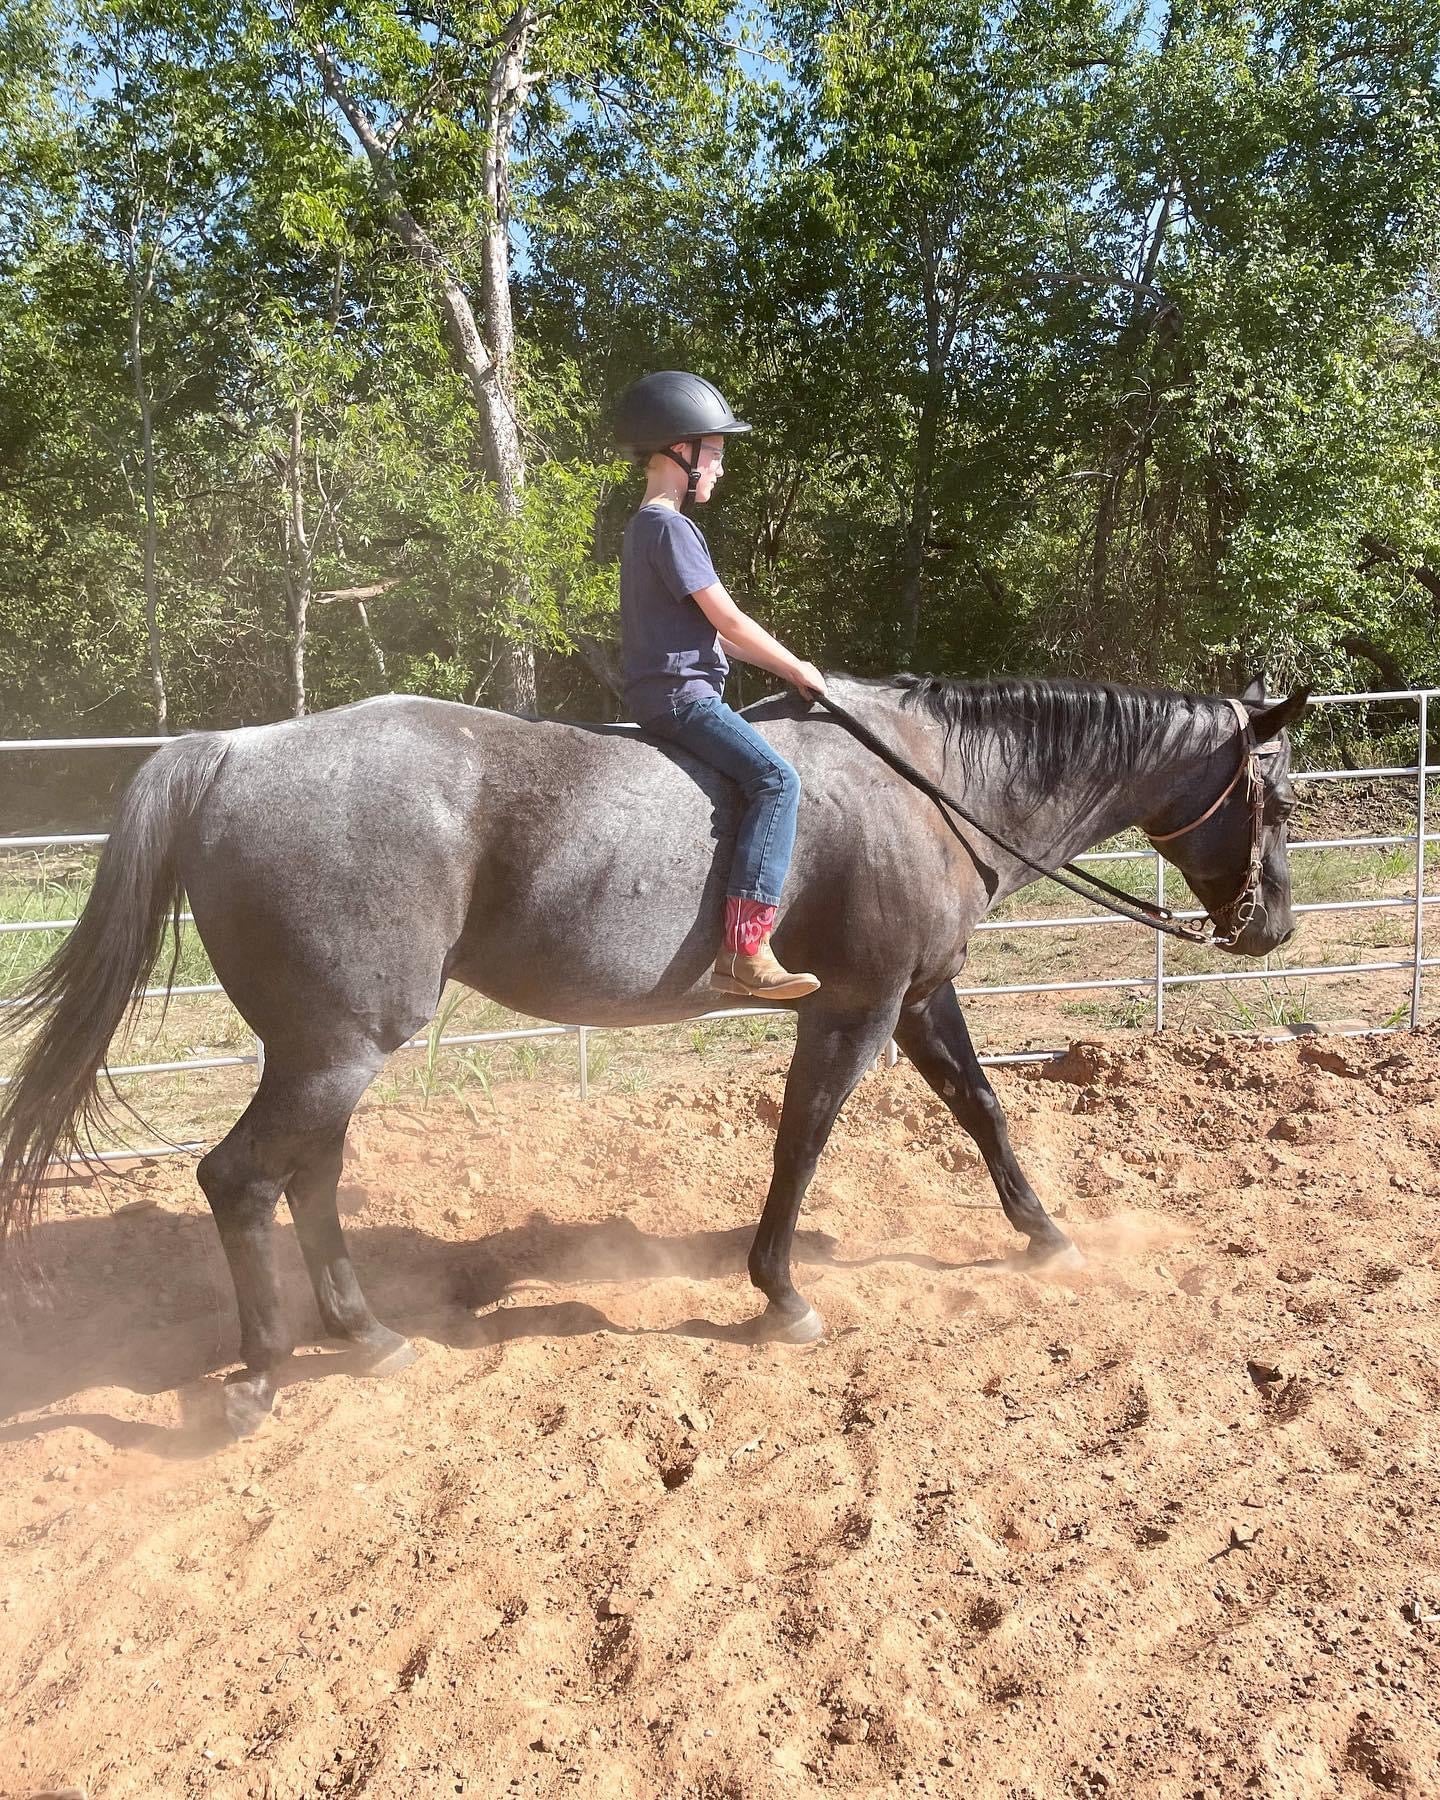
[{"x1": 619, "y1": 502, "x2": 731, "y2": 725}]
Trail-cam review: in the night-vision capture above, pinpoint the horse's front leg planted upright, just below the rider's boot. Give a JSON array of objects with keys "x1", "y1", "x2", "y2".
[{"x1": 751, "y1": 1001, "x2": 895, "y2": 1345}]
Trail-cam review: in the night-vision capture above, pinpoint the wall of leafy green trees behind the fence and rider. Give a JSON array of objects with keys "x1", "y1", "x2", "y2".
[{"x1": 0, "y1": 0, "x2": 1440, "y2": 731}]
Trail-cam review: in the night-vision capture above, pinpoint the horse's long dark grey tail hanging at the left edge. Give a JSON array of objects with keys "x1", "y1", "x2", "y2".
[{"x1": 0, "y1": 733, "x2": 227, "y2": 1246}]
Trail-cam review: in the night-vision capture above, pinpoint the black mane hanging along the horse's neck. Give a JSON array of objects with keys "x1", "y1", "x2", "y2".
[{"x1": 895, "y1": 675, "x2": 1206, "y2": 792}]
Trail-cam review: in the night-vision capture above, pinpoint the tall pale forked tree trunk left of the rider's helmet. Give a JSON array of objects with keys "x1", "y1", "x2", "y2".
[{"x1": 311, "y1": 29, "x2": 536, "y2": 713}]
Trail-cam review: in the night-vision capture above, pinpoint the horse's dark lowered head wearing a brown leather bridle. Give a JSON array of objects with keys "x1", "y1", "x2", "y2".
[{"x1": 1147, "y1": 680, "x2": 1310, "y2": 956}]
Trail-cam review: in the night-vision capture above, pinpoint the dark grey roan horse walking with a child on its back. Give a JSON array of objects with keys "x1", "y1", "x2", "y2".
[{"x1": 0, "y1": 677, "x2": 1305, "y2": 1433}]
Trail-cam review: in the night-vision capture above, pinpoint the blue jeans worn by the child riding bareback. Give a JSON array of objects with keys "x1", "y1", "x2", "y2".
[{"x1": 644, "y1": 693, "x2": 799, "y2": 905}]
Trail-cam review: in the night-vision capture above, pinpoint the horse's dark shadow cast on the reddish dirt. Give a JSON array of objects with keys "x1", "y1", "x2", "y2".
[{"x1": 0, "y1": 1208, "x2": 986, "y2": 1456}]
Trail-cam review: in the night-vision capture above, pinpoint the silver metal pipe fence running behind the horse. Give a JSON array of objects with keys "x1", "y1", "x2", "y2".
[{"x1": 0, "y1": 688, "x2": 1440, "y2": 1161}]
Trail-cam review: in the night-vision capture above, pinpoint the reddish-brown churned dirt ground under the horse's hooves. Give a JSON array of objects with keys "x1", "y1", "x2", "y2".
[{"x1": 0, "y1": 1028, "x2": 1440, "y2": 1800}]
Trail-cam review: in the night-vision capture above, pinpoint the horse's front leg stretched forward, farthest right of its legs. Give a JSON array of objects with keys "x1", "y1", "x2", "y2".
[{"x1": 895, "y1": 981, "x2": 1078, "y2": 1260}]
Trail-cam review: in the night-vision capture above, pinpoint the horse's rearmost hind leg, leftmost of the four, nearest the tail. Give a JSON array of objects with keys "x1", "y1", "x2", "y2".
[{"x1": 196, "y1": 1057, "x2": 383, "y2": 1436}]
